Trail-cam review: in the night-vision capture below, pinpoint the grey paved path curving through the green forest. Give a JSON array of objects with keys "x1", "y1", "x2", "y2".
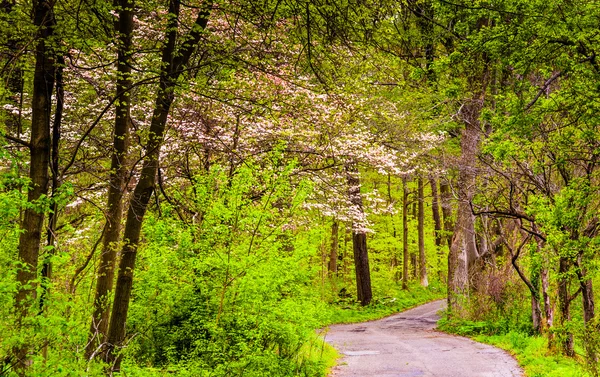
[{"x1": 325, "y1": 300, "x2": 523, "y2": 377}]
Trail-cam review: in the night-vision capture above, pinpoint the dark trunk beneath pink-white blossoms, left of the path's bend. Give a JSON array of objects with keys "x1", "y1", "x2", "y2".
[{"x1": 346, "y1": 164, "x2": 373, "y2": 306}]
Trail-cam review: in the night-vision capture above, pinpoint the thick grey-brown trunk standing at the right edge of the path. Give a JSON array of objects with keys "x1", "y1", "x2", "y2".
[{"x1": 448, "y1": 100, "x2": 482, "y2": 311}]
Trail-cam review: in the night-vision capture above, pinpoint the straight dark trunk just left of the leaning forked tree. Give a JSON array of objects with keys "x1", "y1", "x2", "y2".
[{"x1": 85, "y1": 0, "x2": 134, "y2": 359}]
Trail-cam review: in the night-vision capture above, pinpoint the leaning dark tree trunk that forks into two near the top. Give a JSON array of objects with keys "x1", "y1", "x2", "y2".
[{"x1": 106, "y1": 0, "x2": 212, "y2": 371}]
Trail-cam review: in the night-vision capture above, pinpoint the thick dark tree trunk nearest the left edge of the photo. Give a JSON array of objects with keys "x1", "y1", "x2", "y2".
[{"x1": 14, "y1": 1, "x2": 55, "y2": 373}]
